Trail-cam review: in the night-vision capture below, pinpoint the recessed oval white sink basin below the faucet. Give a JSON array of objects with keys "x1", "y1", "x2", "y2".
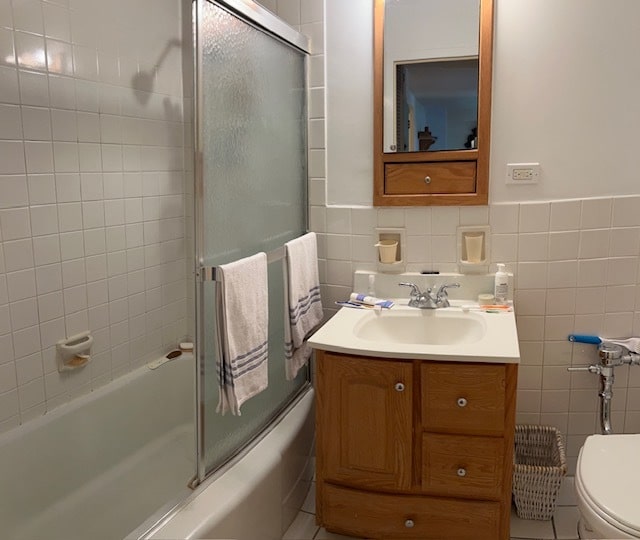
[{"x1": 353, "y1": 309, "x2": 487, "y2": 345}]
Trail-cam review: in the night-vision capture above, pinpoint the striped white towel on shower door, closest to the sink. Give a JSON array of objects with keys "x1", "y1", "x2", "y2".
[{"x1": 284, "y1": 233, "x2": 323, "y2": 380}]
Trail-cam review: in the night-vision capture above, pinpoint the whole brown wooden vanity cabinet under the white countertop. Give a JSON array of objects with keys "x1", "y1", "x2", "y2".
[{"x1": 316, "y1": 351, "x2": 517, "y2": 540}]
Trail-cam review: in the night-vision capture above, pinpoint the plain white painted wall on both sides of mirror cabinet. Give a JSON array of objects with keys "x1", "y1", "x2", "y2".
[{"x1": 326, "y1": 0, "x2": 640, "y2": 205}]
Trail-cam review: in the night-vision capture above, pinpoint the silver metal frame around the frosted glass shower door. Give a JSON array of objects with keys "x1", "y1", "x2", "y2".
[{"x1": 190, "y1": 0, "x2": 311, "y2": 487}]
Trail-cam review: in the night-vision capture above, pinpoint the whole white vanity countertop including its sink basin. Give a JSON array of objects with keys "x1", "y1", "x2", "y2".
[{"x1": 309, "y1": 298, "x2": 520, "y2": 363}]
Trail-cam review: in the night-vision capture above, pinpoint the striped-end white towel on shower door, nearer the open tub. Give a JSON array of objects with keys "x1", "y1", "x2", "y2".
[{"x1": 217, "y1": 253, "x2": 269, "y2": 415}]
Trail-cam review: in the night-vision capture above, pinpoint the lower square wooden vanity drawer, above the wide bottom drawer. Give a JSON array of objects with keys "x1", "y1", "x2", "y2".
[{"x1": 422, "y1": 433, "x2": 504, "y2": 499}]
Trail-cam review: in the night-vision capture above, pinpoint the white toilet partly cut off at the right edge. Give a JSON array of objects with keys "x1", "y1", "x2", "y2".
[{"x1": 575, "y1": 434, "x2": 640, "y2": 540}]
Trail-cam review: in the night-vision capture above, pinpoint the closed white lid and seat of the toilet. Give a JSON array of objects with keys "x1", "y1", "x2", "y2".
[{"x1": 577, "y1": 434, "x2": 640, "y2": 534}]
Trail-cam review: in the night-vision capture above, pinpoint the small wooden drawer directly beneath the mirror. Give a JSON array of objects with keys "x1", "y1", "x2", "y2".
[{"x1": 384, "y1": 161, "x2": 476, "y2": 195}]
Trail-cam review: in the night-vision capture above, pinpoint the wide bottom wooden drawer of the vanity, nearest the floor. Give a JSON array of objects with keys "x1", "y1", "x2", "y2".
[{"x1": 322, "y1": 484, "x2": 500, "y2": 540}]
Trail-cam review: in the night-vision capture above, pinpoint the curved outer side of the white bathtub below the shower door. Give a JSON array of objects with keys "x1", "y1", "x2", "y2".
[{"x1": 146, "y1": 389, "x2": 315, "y2": 540}]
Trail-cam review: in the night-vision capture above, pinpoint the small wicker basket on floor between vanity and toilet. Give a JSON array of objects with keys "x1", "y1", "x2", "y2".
[{"x1": 513, "y1": 424, "x2": 567, "y2": 520}]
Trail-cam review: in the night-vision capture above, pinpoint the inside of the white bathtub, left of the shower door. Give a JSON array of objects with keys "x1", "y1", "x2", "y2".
[{"x1": 0, "y1": 354, "x2": 195, "y2": 540}]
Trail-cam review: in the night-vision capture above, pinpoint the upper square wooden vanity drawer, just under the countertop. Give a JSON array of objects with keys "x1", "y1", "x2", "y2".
[{"x1": 420, "y1": 362, "x2": 506, "y2": 435}]
